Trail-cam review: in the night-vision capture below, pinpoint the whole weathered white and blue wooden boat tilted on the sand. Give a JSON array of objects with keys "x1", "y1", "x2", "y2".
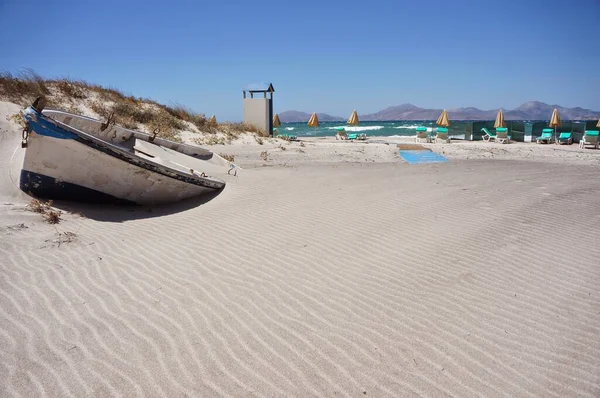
[{"x1": 20, "y1": 99, "x2": 231, "y2": 204}]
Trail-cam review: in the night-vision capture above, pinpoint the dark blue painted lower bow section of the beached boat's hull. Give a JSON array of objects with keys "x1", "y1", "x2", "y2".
[{"x1": 19, "y1": 170, "x2": 136, "y2": 204}]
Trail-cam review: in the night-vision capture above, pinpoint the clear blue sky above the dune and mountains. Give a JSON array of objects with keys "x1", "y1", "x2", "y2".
[{"x1": 0, "y1": 0, "x2": 600, "y2": 120}]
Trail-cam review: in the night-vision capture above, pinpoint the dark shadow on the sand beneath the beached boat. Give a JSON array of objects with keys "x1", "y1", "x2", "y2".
[{"x1": 52, "y1": 191, "x2": 222, "y2": 223}]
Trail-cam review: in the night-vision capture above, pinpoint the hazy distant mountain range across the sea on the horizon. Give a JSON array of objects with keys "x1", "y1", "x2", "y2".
[{"x1": 279, "y1": 101, "x2": 600, "y2": 123}]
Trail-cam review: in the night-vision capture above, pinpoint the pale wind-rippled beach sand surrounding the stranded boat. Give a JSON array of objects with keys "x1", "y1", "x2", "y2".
[{"x1": 0, "y1": 103, "x2": 600, "y2": 397}]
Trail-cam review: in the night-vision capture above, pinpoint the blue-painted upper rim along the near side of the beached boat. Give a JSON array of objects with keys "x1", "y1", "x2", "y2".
[{"x1": 23, "y1": 107, "x2": 225, "y2": 191}]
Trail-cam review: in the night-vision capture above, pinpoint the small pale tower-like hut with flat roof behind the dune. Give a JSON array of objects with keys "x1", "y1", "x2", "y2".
[{"x1": 243, "y1": 83, "x2": 275, "y2": 135}]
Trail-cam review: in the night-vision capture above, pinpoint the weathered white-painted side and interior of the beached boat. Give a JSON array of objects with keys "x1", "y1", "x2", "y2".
[{"x1": 23, "y1": 109, "x2": 229, "y2": 204}]
